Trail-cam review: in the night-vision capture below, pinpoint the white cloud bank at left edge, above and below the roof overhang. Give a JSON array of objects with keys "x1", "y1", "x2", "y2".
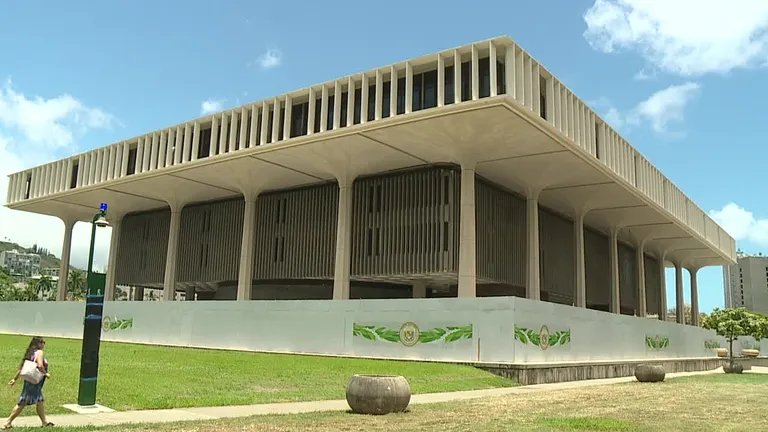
[{"x1": 0, "y1": 81, "x2": 117, "y2": 268}]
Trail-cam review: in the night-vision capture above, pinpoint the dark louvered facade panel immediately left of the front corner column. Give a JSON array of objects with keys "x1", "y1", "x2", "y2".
[{"x1": 351, "y1": 167, "x2": 460, "y2": 278}]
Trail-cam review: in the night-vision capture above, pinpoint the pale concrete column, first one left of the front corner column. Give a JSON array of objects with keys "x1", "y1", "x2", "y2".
[{"x1": 333, "y1": 179, "x2": 352, "y2": 300}]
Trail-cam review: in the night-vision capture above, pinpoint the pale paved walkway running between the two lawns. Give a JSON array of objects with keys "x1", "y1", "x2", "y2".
[{"x1": 14, "y1": 367, "x2": 768, "y2": 427}]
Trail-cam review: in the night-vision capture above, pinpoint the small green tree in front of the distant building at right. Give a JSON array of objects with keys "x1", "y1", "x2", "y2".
[{"x1": 702, "y1": 308, "x2": 768, "y2": 368}]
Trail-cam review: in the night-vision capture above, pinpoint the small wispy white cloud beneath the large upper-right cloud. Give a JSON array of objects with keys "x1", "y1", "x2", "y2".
[{"x1": 626, "y1": 82, "x2": 701, "y2": 133}]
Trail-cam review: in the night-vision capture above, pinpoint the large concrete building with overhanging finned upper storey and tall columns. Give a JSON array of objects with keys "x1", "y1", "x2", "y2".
[{"x1": 7, "y1": 37, "x2": 736, "y2": 324}]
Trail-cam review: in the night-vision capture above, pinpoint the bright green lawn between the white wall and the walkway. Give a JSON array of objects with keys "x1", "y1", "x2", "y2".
[{"x1": 0, "y1": 335, "x2": 515, "y2": 417}]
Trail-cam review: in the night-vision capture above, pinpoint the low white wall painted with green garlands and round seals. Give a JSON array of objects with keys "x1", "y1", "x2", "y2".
[{"x1": 0, "y1": 297, "x2": 756, "y2": 363}]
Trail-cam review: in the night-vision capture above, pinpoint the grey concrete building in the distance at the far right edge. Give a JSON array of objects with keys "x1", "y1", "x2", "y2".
[{"x1": 723, "y1": 253, "x2": 768, "y2": 314}]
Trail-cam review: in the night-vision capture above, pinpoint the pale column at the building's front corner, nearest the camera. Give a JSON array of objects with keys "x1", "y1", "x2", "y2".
[{"x1": 458, "y1": 166, "x2": 477, "y2": 297}]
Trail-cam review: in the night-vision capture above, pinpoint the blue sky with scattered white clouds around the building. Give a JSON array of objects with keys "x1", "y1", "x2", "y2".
[{"x1": 0, "y1": 0, "x2": 768, "y2": 311}]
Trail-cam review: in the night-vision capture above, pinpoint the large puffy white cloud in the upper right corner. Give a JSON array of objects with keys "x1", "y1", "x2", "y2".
[{"x1": 584, "y1": 0, "x2": 768, "y2": 76}]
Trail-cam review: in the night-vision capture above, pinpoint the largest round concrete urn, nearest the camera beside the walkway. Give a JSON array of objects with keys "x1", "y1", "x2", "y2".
[{"x1": 347, "y1": 375, "x2": 411, "y2": 415}]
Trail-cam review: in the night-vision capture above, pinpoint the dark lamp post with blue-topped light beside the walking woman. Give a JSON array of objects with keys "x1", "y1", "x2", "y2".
[{"x1": 77, "y1": 203, "x2": 109, "y2": 406}]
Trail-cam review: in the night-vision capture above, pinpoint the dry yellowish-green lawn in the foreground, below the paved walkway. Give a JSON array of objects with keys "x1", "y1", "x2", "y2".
[{"x1": 33, "y1": 374, "x2": 768, "y2": 432}]
